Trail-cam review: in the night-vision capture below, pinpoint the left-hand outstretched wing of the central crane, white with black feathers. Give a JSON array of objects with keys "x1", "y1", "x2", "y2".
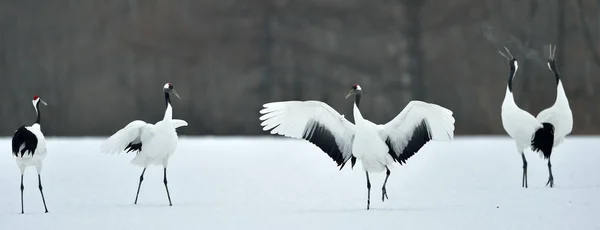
[{"x1": 259, "y1": 101, "x2": 354, "y2": 166}]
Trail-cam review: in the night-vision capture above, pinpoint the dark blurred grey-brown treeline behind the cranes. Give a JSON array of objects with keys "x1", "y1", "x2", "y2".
[{"x1": 0, "y1": 0, "x2": 600, "y2": 136}]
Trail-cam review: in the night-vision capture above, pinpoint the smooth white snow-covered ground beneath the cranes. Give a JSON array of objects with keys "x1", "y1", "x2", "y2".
[{"x1": 0, "y1": 137, "x2": 600, "y2": 230}]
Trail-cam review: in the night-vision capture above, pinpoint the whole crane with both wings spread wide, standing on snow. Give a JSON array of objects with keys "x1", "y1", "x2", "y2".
[{"x1": 259, "y1": 84, "x2": 454, "y2": 209}]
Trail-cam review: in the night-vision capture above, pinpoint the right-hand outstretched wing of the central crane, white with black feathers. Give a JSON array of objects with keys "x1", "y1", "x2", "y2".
[{"x1": 378, "y1": 101, "x2": 454, "y2": 164}]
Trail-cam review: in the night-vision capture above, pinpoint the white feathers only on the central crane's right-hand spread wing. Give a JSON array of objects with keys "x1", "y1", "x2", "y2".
[{"x1": 378, "y1": 101, "x2": 454, "y2": 160}]
